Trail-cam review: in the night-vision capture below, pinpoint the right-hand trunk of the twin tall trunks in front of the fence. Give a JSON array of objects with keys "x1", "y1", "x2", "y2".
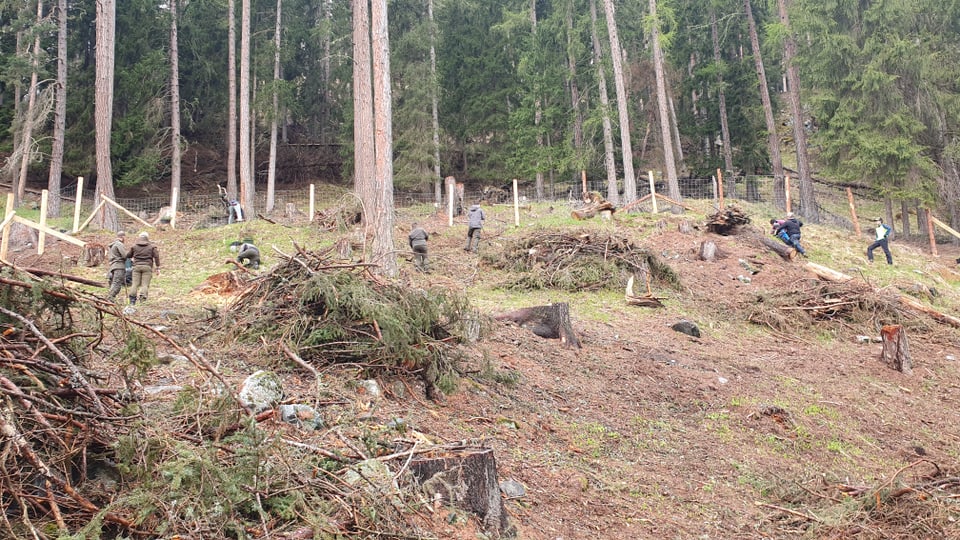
[{"x1": 370, "y1": 0, "x2": 397, "y2": 277}]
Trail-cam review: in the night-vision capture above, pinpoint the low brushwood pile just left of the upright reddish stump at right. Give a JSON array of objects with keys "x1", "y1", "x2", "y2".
[{"x1": 746, "y1": 280, "x2": 920, "y2": 332}]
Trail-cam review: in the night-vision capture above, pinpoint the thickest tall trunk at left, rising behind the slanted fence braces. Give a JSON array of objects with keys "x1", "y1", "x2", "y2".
[{"x1": 93, "y1": 0, "x2": 120, "y2": 231}]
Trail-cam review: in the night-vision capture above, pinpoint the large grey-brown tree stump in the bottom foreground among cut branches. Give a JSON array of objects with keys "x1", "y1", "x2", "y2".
[{"x1": 410, "y1": 447, "x2": 509, "y2": 538}]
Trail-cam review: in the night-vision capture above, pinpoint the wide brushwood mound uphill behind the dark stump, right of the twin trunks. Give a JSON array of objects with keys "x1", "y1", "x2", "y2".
[{"x1": 493, "y1": 230, "x2": 680, "y2": 292}]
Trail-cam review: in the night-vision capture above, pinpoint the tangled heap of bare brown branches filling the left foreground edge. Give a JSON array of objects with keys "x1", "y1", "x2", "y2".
[{"x1": 0, "y1": 267, "x2": 148, "y2": 538}]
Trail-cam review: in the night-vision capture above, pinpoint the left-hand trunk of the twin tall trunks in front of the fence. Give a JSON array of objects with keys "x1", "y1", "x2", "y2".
[{"x1": 353, "y1": 0, "x2": 376, "y2": 211}]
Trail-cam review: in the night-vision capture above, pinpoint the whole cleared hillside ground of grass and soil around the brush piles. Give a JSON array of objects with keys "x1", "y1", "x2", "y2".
[{"x1": 1, "y1": 195, "x2": 960, "y2": 540}]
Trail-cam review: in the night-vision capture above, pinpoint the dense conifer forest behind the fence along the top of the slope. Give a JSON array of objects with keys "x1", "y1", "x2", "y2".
[{"x1": 0, "y1": 0, "x2": 960, "y2": 228}]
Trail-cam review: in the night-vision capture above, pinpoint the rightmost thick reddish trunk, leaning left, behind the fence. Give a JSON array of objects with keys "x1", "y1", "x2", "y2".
[{"x1": 777, "y1": 0, "x2": 820, "y2": 223}]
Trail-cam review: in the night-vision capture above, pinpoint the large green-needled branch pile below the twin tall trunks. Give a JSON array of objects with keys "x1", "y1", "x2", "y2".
[{"x1": 228, "y1": 247, "x2": 478, "y2": 393}]
